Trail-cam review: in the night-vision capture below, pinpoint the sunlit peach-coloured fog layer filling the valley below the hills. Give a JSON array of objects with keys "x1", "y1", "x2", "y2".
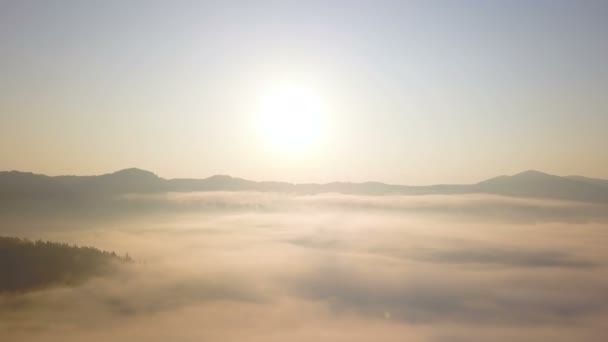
[{"x1": 0, "y1": 193, "x2": 608, "y2": 342}]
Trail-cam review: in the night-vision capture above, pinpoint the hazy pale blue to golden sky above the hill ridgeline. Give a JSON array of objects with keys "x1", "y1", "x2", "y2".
[{"x1": 0, "y1": 0, "x2": 608, "y2": 184}]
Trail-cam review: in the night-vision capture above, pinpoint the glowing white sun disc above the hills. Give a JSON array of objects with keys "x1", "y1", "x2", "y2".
[{"x1": 257, "y1": 83, "x2": 329, "y2": 155}]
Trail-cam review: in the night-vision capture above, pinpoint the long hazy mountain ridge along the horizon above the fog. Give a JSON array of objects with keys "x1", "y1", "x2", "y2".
[{"x1": 0, "y1": 168, "x2": 608, "y2": 203}]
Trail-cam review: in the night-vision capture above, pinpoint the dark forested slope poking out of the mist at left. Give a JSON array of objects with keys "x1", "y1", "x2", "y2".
[{"x1": 0, "y1": 236, "x2": 131, "y2": 292}]
